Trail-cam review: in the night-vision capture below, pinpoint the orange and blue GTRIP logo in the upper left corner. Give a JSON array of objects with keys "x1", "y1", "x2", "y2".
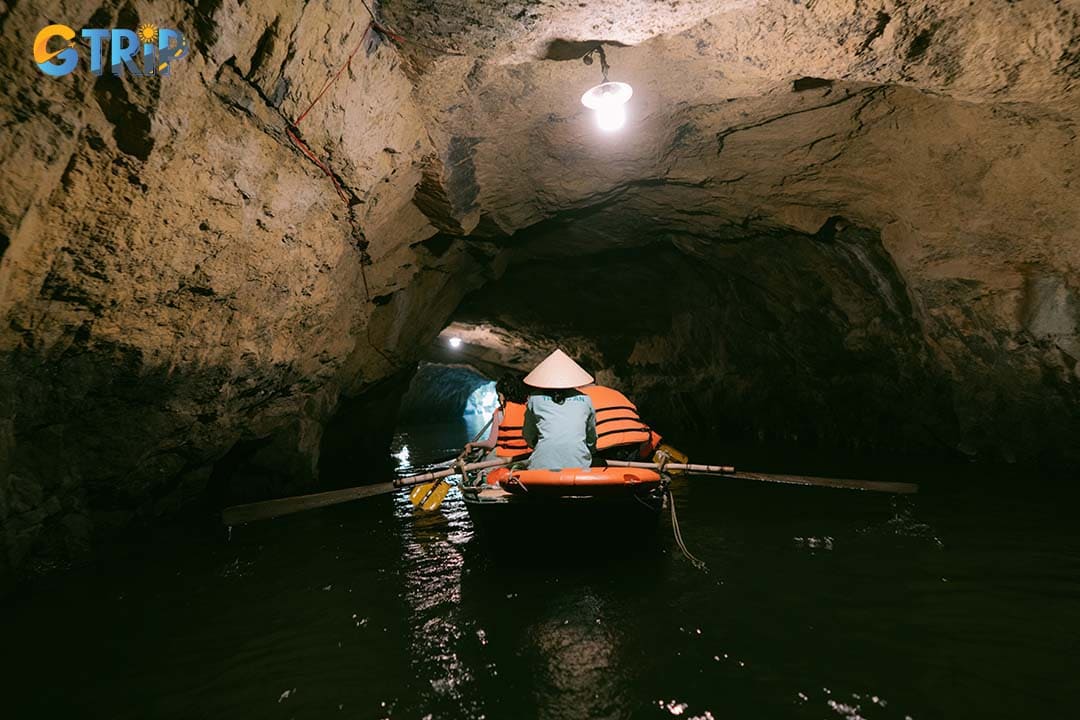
[{"x1": 33, "y1": 23, "x2": 188, "y2": 78}]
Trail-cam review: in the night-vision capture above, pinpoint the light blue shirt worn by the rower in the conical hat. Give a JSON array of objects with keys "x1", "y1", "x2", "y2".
[{"x1": 522, "y1": 393, "x2": 596, "y2": 470}]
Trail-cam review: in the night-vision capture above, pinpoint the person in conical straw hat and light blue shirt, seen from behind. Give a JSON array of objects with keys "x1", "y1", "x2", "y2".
[{"x1": 522, "y1": 350, "x2": 596, "y2": 470}]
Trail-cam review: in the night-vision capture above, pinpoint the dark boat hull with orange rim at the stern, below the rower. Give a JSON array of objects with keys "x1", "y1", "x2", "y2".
[{"x1": 461, "y1": 467, "x2": 669, "y2": 547}]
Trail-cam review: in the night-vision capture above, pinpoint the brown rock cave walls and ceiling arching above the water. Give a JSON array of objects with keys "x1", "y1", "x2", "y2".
[{"x1": 0, "y1": 0, "x2": 1080, "y2": 718}]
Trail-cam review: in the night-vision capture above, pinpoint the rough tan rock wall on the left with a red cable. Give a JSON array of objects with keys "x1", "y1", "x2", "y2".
[{"x1": 0, "y1": 2, "x2": 486, "y2": 576}]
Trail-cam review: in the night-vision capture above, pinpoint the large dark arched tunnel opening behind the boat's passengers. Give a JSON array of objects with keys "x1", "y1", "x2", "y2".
[{"x1": 388, "y1": 212, "x2": 953, "y2": 479}]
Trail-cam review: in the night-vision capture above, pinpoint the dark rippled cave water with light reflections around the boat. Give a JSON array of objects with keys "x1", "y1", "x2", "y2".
[{"x1": 0, "y1": 422, "x2": 1080, "y2": 720}]
